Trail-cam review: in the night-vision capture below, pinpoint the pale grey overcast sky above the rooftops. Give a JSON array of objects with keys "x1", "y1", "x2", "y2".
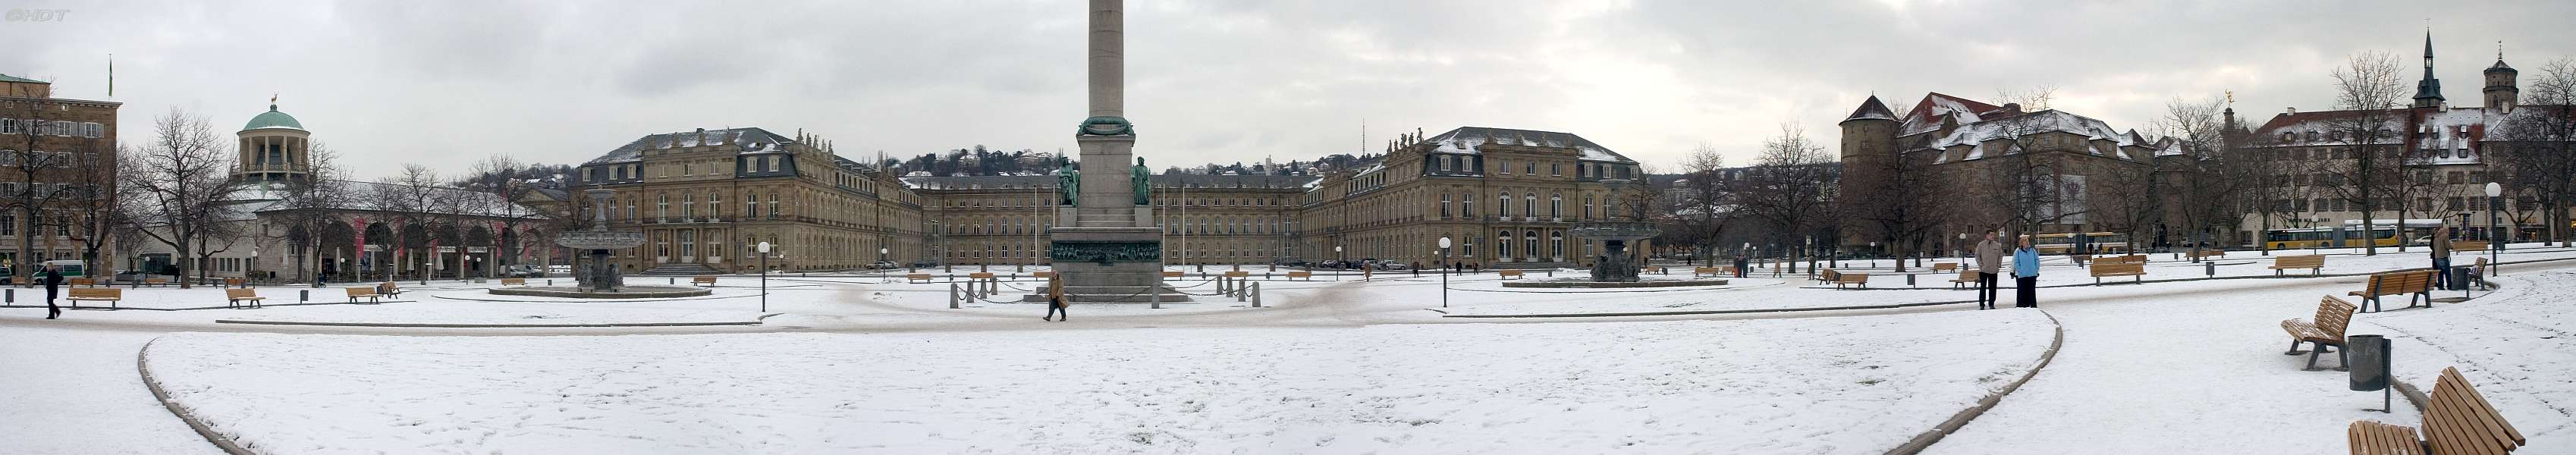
[{"x1": 0, "y1": 0, "x2": 2576, "y2": 177}]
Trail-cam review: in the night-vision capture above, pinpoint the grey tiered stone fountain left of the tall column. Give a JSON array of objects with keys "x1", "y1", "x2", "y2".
[{"x1": 492, "y1": 187, "x2": 714, "y2": 298}]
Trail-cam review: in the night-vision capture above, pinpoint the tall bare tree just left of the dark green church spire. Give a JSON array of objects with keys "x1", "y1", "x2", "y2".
[{"x1": 2318, "y1": 52, "x2": 2406, "y2": 255}]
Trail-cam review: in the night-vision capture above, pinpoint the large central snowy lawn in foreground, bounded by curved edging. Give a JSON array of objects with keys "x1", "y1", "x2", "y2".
[{"x1": 147, "y1": 311, "x2": 2053, "y2": 453}]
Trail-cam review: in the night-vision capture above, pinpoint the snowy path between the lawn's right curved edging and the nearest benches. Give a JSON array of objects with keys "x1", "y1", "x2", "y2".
[{"x1": 1927, "y1": 262, "x2": 2568, "y2": 455}]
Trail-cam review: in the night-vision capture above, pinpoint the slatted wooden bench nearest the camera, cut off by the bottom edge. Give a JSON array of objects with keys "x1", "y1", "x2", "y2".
[{"x1": 2344, "y1": 368, "x2": 2527, "y2": 455}]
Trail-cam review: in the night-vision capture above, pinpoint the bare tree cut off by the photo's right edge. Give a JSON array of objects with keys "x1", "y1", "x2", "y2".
[{"x1": 2491, "y1": 59, "x2": 2576, "y2": 246}]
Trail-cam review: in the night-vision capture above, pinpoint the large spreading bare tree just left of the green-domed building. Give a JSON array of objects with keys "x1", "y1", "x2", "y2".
[{"x1": 118, "y1": 108, "x2": 240, "y2": 288}]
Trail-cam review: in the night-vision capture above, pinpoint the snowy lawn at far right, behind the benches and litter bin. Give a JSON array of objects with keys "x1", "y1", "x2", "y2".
[{"x1": 2352, "y1": 268, "x2": 2576, "y2": 453}]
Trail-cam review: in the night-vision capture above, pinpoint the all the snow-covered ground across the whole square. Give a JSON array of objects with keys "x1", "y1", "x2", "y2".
[{"x1": 0, "y1": 244, "x2": 2576, "y2": 453}]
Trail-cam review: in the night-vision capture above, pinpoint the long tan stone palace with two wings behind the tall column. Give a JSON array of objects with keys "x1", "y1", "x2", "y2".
[{"x1": 561, "y1": 126, "x2": 1644, "y2": 272}]
